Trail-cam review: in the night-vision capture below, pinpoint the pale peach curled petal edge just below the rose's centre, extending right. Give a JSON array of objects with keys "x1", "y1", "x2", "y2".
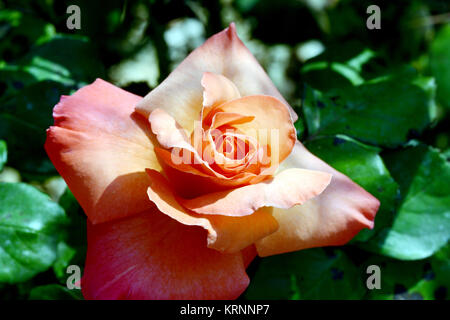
[{"x1": 180, "y1": 168, "x2": 331, "y2": 217}]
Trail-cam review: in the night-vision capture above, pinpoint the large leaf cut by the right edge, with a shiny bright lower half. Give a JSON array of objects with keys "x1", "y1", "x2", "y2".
[{"x1": 367, "y1": 145, "x2": 450, "y2": 260}]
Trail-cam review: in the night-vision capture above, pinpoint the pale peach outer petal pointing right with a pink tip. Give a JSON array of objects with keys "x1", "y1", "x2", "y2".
[{"x1": 256, "y1": 142, "x2": 380, "y2": 256}]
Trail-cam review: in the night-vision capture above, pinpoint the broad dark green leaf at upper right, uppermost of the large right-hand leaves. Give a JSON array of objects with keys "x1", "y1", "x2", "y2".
[{"x1": 303, "y1": 77, "x2": 435, "y2": 147}]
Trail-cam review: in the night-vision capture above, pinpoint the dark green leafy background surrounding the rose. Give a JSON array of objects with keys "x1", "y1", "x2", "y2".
[{"x1": 0, "y1": 0, "x2": 450, "y2": 299}]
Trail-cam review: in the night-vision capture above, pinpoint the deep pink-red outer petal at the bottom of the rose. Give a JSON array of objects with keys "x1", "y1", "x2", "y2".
[{"x1": 82, "y1": 209, "x2": 251, "y2": 300}]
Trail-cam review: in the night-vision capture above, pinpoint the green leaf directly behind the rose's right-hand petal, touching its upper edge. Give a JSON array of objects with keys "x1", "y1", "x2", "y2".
[{"x1": 305, "y1": 135, "x2": 399, "y2": 241}]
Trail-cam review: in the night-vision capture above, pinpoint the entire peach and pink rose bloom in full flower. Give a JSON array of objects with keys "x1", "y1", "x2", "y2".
[{"x1": 45, "y1": 24, "x2": 379, "y2": 299}]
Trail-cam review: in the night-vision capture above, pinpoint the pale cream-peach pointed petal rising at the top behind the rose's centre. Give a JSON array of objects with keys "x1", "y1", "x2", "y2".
[{"x1": 136, "y1": 24, "x2": 298, "y2": 133}]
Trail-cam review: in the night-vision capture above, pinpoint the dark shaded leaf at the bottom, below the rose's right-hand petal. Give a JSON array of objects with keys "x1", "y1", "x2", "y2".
[{"x1": 245, "y1": 248, "x2": 365, "y2": 299}]
